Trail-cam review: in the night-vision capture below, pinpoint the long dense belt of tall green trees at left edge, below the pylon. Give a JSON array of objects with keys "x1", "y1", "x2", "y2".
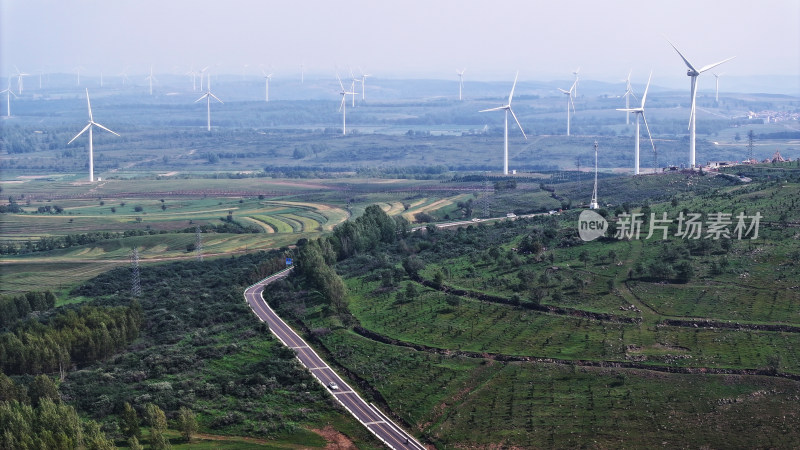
[{"x1": 0, "y1": 301, "x2": 142, "y2": 374}]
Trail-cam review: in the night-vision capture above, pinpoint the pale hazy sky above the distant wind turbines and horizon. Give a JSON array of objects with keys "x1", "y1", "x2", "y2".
[{"x1": 0, "y1": 0, "x2": 800, "y2": 85}]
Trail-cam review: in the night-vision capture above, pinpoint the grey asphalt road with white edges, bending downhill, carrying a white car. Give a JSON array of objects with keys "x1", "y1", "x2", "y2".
[{"x1": 244, "y1": 268, "x2": 425, "y2": 450}]
